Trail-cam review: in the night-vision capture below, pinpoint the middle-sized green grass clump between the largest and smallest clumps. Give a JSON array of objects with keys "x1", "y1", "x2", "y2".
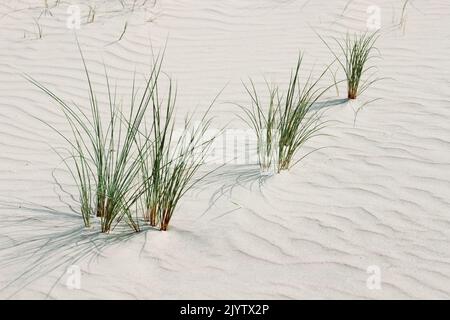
[{"x1": 243, "y1": 55, "x2": 334, "y2": 172}]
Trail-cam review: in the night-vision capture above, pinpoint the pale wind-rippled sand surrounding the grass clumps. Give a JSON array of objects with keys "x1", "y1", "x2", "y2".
[{"x1": 0, "y1": 0, "x2": 450, "y2": 299}]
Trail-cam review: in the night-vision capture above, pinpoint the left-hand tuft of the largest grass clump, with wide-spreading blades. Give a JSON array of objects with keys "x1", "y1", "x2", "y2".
[{"x1": 28, "y1": 44, "x2": 162, "y2": 232}]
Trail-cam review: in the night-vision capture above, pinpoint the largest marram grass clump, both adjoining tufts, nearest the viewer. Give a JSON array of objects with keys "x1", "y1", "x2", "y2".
[{"x1": 28, "y1": 43, "x2": 214, "y2": 232}]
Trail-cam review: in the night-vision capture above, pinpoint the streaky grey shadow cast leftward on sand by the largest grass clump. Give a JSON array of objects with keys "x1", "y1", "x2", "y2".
[{"x1": 0, "y1": 201, "x2": 155, "y2": 299}]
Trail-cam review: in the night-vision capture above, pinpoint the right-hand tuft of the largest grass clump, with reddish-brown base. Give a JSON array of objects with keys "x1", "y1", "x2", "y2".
[{"x1": 140, "y1": 81, "x2": 214, "y2": 231}]
